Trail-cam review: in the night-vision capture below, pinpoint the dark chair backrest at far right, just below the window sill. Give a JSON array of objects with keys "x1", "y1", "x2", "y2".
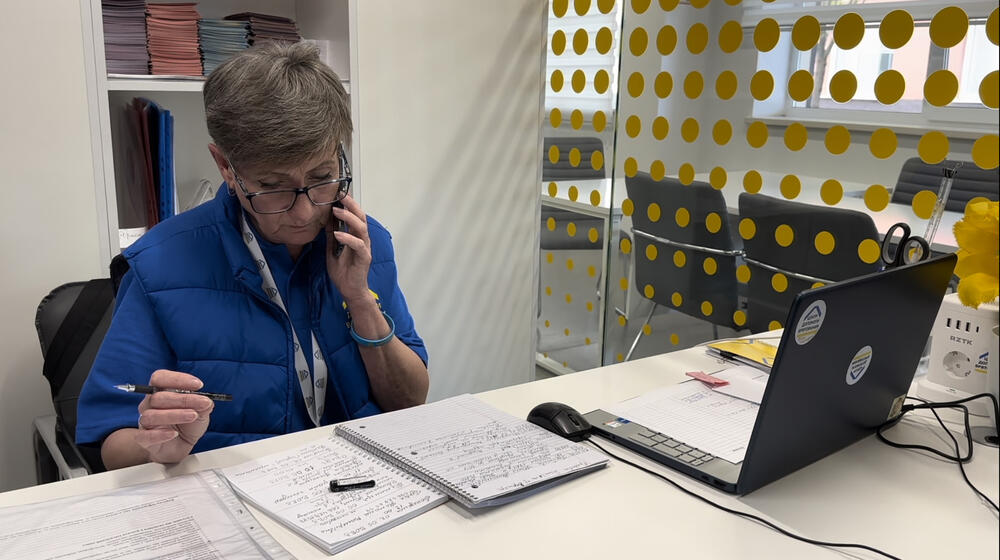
[{"x1": 892, "y1": 157, "x2": 1000, "y2": 212}]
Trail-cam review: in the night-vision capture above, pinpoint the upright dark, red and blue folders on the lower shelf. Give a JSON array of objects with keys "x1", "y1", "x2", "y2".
[{"x1": 114, "y1": 98, "x2": 176, "y2": 241}]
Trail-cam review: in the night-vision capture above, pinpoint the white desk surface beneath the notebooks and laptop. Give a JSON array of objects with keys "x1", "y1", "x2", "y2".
[{"x1": 0, "y1": 349, "x2": 1000, "y2": 560}]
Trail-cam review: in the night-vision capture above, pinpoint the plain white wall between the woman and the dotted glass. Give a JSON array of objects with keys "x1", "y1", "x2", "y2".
[{"x1": 352, "y1": 0, "x2": 546, "y2": 400}]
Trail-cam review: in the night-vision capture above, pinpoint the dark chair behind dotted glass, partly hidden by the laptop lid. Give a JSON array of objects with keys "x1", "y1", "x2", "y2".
[{"x1": 740, "y1": 193, "x2": 881, "y2": 333}]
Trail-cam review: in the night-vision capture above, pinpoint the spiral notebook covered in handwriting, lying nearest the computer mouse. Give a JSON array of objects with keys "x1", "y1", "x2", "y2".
[{"x1": 336, "y1": 395, "x2": 608, "y2": 508}]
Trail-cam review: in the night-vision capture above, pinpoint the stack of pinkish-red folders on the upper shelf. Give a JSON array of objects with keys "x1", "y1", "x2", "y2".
[{"x1": 146, "y1": 2, "x2": 202, "y2": 76}]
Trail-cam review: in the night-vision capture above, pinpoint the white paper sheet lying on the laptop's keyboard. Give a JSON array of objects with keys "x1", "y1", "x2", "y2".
[{"x1": 602, "y1": 380, "x2": 760, "y2": 463}]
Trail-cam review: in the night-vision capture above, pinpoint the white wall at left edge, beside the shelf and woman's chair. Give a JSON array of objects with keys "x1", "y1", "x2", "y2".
[{"x1": 0, "y1": 0, "x2": 101, "y2": 491}]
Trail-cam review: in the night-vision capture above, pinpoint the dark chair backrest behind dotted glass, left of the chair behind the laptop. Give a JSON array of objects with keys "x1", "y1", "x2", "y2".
[{"x1": 625, "y1": 173, "x2": 739, "y2": 328}]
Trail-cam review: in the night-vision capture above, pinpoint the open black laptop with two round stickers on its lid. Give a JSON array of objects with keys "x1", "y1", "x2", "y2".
[{"x1": 584, "y1": 254, "x2": 957, "y2": 494}]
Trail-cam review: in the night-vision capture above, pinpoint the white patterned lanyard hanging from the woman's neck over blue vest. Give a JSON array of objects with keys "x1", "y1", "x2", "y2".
[{"x1": 240, "y1": 212, "x2": 327, "y2": 426}]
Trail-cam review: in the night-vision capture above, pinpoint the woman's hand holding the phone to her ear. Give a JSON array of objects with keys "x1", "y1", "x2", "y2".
[{"x1": 326, "y1": 196, "x2": 372, "y2": 303}]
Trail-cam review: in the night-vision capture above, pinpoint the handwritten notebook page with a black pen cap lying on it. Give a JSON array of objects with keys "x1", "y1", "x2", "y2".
[{"x1": 227, "y1": 434, "x2": 447, "y2": 553}]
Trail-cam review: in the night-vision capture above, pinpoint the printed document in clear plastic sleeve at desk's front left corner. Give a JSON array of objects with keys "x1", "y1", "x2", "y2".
[{"x1": 0, "y1": 471, "x2": 291, "y2": 560}]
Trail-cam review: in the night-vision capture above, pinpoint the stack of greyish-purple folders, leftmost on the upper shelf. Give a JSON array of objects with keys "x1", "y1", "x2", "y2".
[{"x1": 101, "y1": 0, "x2": 149, "y2": 74}]
